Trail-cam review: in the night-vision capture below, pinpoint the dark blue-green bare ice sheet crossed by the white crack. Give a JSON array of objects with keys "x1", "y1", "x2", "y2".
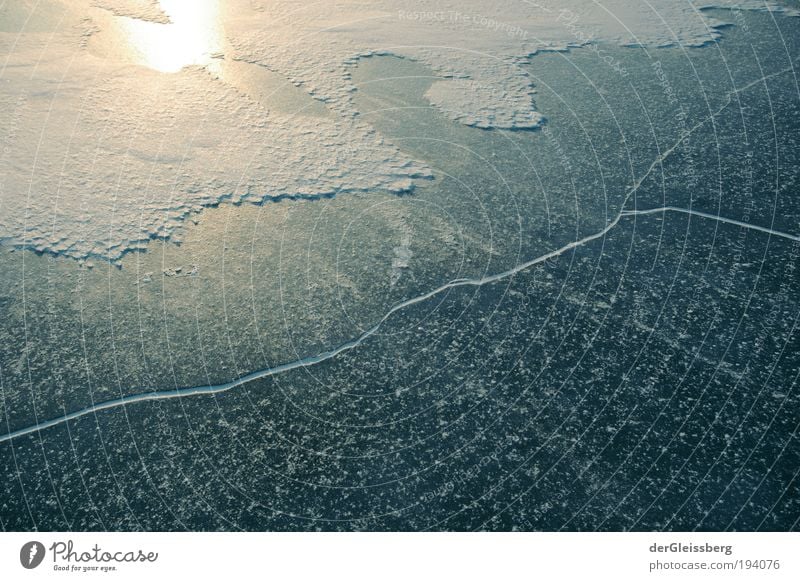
[{"x1": 0, "y1": 12, "x2": 800, "y2": 530}]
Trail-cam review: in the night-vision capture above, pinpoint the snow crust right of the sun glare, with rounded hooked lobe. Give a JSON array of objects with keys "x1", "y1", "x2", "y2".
[{"x1": 231, "y1": 0, "x2": 797, "y2": 128}]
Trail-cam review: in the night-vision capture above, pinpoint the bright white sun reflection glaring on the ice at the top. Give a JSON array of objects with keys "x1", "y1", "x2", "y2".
[{"x1": 119, "y1": 0, "x2": 223, "y2": 73}]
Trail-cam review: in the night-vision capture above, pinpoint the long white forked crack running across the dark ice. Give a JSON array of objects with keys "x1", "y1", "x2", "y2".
[{"x1": 0, "y1": 62, "x2": 800, "y2": 443}]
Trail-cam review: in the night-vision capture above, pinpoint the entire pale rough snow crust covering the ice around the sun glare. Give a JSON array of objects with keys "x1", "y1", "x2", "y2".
[{"x1": 0, "y1": 0, "x2": 796, "y2": 261}]
